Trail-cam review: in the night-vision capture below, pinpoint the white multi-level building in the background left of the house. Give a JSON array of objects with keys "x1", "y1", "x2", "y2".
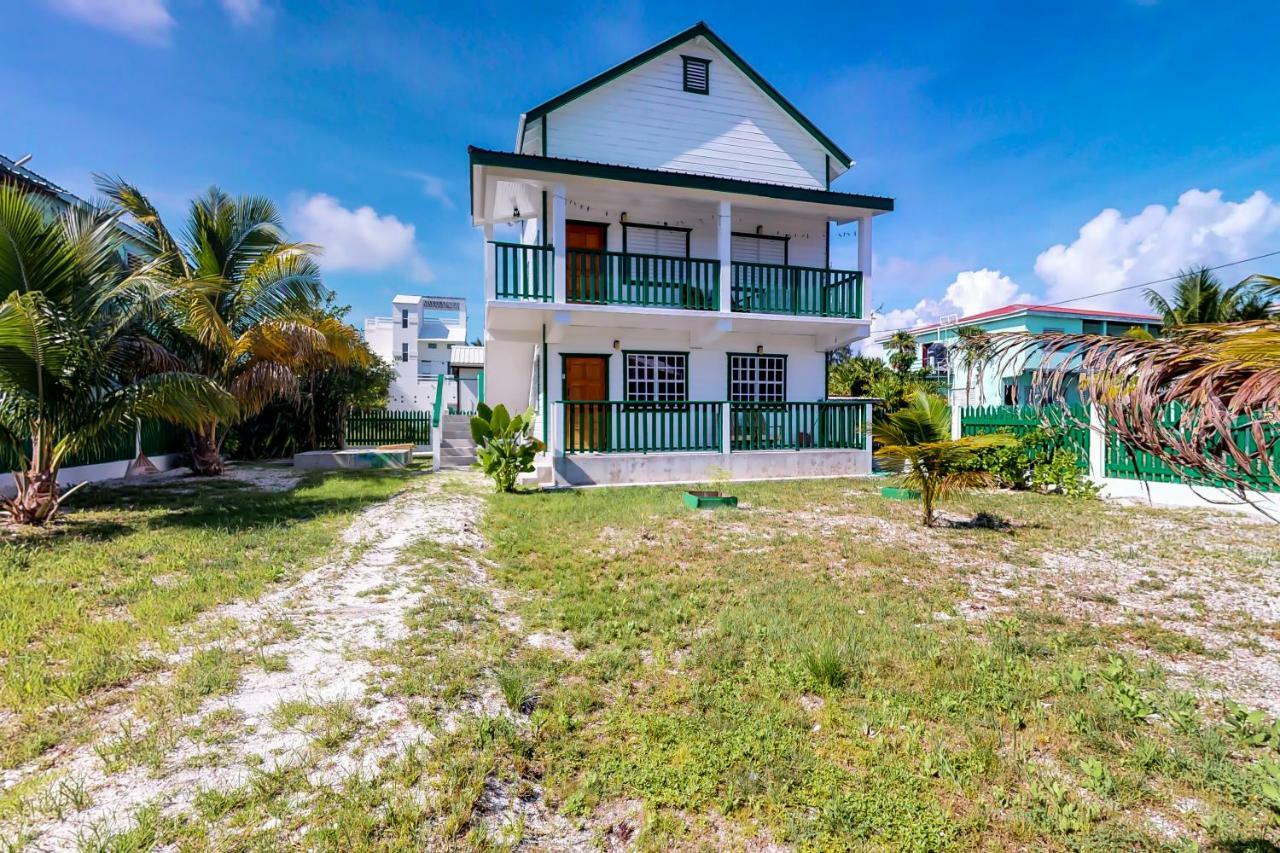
[{"x1": 365, "y1": 295, "x2": 484, "y2": 411}]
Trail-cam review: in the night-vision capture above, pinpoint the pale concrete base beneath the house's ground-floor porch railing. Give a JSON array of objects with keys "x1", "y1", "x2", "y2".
[{"x1": 554, "y1": 450, "x2": 872, "y2": 485}]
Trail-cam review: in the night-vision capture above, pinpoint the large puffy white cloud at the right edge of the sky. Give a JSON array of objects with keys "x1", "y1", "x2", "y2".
[{"x1": 1036, "y1": 190, "x2": 1280, "y2": 310}]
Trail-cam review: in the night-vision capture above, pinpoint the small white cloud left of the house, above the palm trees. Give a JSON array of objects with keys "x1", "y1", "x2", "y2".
[{"x1": 289, "y1": 192, "x2": 435, "y2": 282}]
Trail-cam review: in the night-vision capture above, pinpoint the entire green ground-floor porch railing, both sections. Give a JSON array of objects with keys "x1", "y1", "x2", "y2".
[{"x1": 561, "y1": 400, "x2": 868, "y2": 453}]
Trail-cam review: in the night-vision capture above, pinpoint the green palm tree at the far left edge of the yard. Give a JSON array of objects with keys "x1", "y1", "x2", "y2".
[{"x1": 0, "y1": 187, "x2": 234, "y2": 524}]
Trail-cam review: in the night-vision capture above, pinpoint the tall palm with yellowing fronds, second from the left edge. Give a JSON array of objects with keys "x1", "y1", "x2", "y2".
[{"x1": 99, "y1": 175, "x2": 367, "y2": 474}]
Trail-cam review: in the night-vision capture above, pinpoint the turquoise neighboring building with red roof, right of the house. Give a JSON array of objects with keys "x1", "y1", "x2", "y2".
[{"x1": 910, "y1": 304, "x2": 1160, "y2": 406}]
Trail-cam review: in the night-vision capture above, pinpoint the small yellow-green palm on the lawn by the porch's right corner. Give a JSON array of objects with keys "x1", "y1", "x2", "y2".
[{"x1": 874, "y1": 391, "x2": 1016, "y2": 528}]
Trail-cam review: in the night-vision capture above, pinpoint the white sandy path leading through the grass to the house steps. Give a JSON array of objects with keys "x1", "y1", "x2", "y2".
[{"x1": 0, "y1": 473, "x2": 506, "y2": 850}]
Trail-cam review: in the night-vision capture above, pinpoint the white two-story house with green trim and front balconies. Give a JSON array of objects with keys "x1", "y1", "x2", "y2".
[{"x1": 470, "y1": 23, "x2": 893, "y2": 485}]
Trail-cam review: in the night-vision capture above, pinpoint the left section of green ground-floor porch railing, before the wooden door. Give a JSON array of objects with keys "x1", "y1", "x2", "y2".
[{"x1": 562, "y1": 400, "x2": 724, "y2": 453}]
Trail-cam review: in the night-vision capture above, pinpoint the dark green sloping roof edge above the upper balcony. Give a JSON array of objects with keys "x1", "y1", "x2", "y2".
[{"x1": 467, "y1": 145, "x2": 893, "y2": 213}]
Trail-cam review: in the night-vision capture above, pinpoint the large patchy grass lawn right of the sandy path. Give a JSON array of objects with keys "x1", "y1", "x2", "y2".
[{"x1": 485, "y1": 480, "x2": 1280, "y2": 849}]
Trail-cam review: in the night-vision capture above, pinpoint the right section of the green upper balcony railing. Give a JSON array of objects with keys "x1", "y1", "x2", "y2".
[{"x1": 731, "y1": 261, "x2": 863, "y2": 318}]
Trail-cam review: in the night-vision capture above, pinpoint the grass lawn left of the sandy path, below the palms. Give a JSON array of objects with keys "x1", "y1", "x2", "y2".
[{"x1": 0, "y1": 469, "x2": 417, "y2": 767}]
